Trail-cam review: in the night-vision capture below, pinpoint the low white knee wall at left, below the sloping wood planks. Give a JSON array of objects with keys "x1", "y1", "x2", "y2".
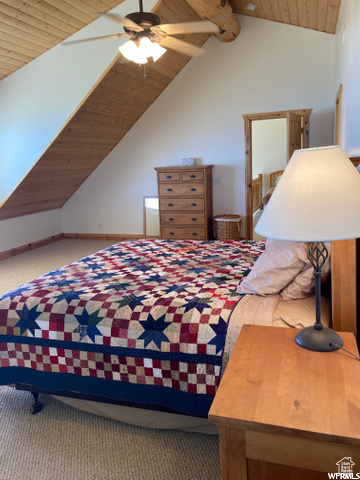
[{"x1": 0, "y1": 209, "x2": 62, "y2": 252}]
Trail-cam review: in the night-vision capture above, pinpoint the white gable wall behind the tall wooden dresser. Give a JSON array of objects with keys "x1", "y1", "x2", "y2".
[{"x1": 61, "y1": 16, "x2": 335, "y2": 238}]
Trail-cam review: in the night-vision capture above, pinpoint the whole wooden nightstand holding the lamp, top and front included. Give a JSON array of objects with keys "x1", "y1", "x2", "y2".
[{"x1": 209, "y1": 325, "x2": 360, "y2": 480}]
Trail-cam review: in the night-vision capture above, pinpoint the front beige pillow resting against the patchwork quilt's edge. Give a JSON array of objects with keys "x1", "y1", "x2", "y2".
[{"x1": 238, "y1": 239, "x2": 309, "y2": 295}]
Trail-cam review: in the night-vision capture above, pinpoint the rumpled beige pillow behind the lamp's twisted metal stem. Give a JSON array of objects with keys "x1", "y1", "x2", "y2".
[{"x1": 280, "y1": 242, "x2": 331, "y2": 300}]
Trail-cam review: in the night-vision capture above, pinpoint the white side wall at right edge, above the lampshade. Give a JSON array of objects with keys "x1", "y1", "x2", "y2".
[{"x1": 333, "y1": 0, "x2": 360, "y2": 156}]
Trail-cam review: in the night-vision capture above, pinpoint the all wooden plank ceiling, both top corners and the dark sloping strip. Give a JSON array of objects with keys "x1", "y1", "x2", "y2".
[{"x1": 0, "y1": 0, "x2": 340, "y2": 220}]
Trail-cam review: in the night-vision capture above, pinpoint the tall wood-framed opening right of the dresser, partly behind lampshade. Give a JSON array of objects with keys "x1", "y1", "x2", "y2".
[{"x1": 244, "y1": 108, "x2": 312, "y2": 240}]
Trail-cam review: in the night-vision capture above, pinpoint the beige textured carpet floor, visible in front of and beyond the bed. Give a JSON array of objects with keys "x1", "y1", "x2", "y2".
[{"x1": 0, "y1": 240, "x2": 220, "y2": 480}]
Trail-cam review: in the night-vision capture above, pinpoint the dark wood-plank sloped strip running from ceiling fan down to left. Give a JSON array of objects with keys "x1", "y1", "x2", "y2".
[{"x1": 0, "y1": 0, "x2": 209, "y2": 220}]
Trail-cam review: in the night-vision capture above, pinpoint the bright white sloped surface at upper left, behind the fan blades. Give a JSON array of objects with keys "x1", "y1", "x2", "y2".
[{"x1": 0, "y1": 0, "x2": 156, "y2": 203}]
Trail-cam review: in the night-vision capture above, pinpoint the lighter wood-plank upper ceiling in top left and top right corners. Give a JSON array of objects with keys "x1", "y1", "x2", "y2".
[{"x1": 0, "y1": 0, "x2": 341, "y2": 80}]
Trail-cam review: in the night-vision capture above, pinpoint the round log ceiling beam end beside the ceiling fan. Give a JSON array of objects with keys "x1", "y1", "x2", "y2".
[{"x1": 186, "y1": 0, "x2": 240, "y2": 42}]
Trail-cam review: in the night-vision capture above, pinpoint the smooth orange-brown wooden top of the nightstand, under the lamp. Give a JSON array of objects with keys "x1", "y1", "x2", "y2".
[{"x1": 209, "y1": 325, "x2": 360, "y2": 445}]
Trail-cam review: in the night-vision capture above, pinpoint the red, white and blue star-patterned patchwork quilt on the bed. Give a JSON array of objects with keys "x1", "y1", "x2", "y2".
[{"x1": 0, "y1": 240, "x2": 264, "y2": 417}]
